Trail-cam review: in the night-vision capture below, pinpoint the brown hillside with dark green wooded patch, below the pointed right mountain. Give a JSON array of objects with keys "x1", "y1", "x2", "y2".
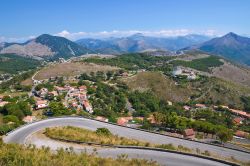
[{"x1": 170, "y1": 51, "x2": 250, "y2": 86}]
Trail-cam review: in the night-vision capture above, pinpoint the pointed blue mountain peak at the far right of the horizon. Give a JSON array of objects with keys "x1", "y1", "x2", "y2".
[{"x1": 188, "y1": 32, "x2": 250, "y2": 65}]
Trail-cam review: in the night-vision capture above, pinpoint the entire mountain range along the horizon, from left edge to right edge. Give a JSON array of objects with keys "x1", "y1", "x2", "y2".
[{"x1": 0, "y1": 32, "x2": 250, "y2": 65}]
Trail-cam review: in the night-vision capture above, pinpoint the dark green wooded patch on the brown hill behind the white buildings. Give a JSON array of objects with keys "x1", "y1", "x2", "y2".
[{"x1": 171, "y1": 56, "x2": 223, "y2": 72}]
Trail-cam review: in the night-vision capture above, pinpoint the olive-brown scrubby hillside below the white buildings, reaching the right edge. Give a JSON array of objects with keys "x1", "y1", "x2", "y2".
[{"x1": 122, "y1": 72, "x2": 250, "y2": 108}]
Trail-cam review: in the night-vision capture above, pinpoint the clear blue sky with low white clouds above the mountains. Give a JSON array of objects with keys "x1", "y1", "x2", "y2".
[{"x1": 0, "y1": 0, "x2": 250, "y2": 42}]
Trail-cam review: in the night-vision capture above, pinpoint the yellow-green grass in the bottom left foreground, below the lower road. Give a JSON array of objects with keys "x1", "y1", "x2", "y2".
[{"x1": 0, "y1": 139, "x2": 158, "y2": 166}]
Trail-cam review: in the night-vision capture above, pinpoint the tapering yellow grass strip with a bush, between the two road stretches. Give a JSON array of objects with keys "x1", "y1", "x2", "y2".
[{"x1": 44, "y1": 126, "x2": 250, "y2": 166}]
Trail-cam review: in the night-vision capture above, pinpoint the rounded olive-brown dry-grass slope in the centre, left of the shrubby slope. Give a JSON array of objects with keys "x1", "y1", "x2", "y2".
[{"x1": 123, "y1": 72, "x2": 192, "y2": 102}]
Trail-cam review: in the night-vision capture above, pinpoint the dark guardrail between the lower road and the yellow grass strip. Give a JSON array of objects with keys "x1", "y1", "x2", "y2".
[{"x1": 45, "y1": 138, "x2": 239, "y2": 166}]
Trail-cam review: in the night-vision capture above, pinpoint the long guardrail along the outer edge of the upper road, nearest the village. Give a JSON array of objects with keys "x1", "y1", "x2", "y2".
[{"x1": 6, "y1": 116, "x2": 250, "y2": 154}]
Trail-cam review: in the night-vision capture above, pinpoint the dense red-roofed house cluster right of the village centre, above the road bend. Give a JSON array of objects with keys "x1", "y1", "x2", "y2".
[{"x1": 55, "y1": 85, "x2": 93, "y2": 113}]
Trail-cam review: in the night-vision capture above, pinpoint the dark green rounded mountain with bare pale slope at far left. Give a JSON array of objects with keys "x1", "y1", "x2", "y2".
[{"x1": 0, "y1": 34, "x2": 89, "y2": 59}]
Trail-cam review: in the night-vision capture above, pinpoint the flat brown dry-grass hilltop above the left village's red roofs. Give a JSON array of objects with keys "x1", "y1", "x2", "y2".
[{"x1": 35, "y1": 62, "x2": 118, "y2": 80}]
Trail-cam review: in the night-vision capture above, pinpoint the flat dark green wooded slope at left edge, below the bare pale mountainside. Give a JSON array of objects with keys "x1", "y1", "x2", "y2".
[{"x1": 0, "y1": 54, "x2": 40, "y2": 74}]
